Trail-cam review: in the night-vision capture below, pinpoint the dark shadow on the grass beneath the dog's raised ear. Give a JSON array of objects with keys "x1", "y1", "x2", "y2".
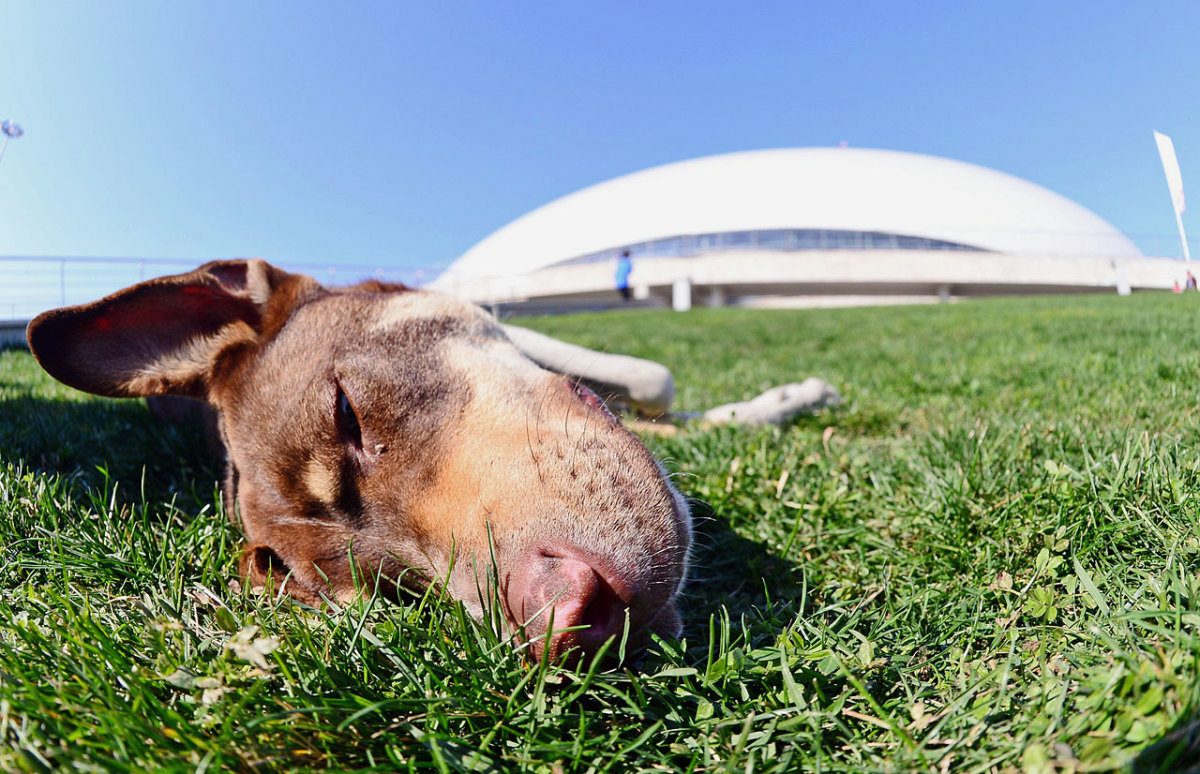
[{"x1": 0, "y1": 394, "x2": 221, "y2": 502}]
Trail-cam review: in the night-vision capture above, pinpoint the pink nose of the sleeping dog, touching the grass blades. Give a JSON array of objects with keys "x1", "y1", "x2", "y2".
[{"x1": 505, "y1": 550, "x2": 635, "y2": 660}]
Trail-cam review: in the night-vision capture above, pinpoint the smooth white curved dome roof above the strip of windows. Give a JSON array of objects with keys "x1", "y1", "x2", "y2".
[{"x1": 443, "y1": 148, "x2": 1141, "y2": 277}]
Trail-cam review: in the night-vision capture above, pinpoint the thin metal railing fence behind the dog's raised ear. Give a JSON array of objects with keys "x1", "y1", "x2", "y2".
[{"x1": 0, "y1": 256, "x2": 440, "y2": 319}]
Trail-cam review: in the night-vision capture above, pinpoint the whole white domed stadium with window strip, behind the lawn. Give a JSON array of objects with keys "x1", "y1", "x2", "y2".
[{"x1": 434, "y1": 148, "x2": 1182, "y2": 310}]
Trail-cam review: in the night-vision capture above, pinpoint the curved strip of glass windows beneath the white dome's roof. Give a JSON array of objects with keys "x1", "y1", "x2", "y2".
[{"x1": 553, "y1": 228, "x2": 990, "y2": 266}]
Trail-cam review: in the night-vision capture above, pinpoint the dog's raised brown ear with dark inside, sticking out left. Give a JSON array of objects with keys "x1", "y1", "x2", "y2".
[{"x1": 26, "y1": 259, "x2": 320, "y2": 398}]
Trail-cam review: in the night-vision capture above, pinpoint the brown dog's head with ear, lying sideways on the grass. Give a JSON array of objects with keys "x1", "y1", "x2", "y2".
[{"x1": 28, "y1": 260, "x2": 691, "y2": 658}]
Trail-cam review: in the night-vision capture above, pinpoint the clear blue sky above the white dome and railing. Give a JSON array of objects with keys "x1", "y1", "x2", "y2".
[{"x1": 0, "y1": 0, "x2": 1200, "y2": 317}]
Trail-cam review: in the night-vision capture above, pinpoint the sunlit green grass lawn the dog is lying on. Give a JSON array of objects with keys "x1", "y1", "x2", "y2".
[{"x1": 0, "y1": 294, "x2": 1200, "y2": 773}]
